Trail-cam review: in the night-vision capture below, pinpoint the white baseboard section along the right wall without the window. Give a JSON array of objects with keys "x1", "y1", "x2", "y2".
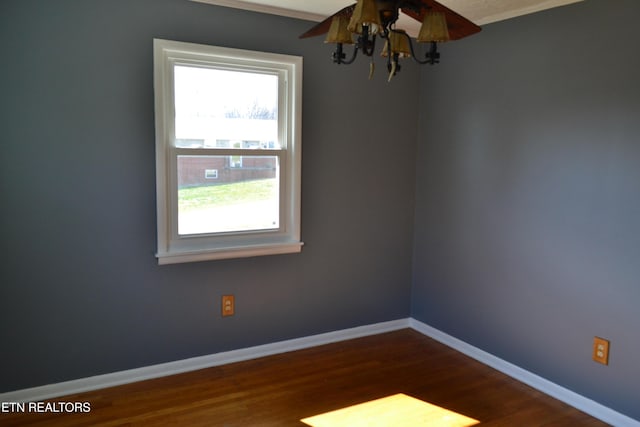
[{"x1": 409, "y1": 318, "x2": 640, "y2": 427}]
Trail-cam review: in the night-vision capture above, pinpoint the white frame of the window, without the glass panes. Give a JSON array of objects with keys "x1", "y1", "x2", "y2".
[{"x1": 154, "y1": 39, "x2": 303, "y2": 264}]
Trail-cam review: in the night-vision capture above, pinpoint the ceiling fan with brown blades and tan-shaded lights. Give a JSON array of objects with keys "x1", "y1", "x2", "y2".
[{"x1": 300, "y1": 0, "x2": 481, "y2": 81}]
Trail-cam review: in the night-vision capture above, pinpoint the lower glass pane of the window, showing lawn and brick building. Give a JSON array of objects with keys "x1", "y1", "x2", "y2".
[{"x1": 178, "y1": 156, "x2": 280, "y2": 235}]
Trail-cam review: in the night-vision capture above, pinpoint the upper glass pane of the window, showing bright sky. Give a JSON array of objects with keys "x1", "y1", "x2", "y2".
[{"x1": 174, "y1": 65, "x2": 280, "y2": 149}]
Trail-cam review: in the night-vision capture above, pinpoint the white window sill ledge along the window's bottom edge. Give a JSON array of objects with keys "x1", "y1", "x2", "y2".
[{"x1": 156, "y1": 242, "x2": 304, "y2": 265}]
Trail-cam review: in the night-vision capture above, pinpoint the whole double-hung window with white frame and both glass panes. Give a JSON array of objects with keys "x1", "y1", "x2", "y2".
[{"x1": 154, "y1": 39, "x2": 302, "y2": 264}]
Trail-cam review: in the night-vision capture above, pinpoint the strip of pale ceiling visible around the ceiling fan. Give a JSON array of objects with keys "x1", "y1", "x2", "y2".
[{"x1": 192, "y1": 0, "x2": 582, "y2": 35}]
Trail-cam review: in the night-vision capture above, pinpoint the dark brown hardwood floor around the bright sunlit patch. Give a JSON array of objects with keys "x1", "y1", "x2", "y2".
[{"x1": 0, "y1": 329, "x2": 606, "y2": 427}]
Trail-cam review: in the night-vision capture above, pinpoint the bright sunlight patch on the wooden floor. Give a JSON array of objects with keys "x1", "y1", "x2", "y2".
[{"x1": 300, "y1": 393, "x2": 480, "y2": 427}]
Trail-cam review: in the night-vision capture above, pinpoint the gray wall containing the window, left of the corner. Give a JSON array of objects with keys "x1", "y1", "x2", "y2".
[{"x1": 0, "y1": 0, "x2": 419, "y2": 392}]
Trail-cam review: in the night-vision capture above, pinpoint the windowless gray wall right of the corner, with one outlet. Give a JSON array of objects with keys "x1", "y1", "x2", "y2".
[{"x1": 412, "y1": 0, "x2": 640, "y2": 419}]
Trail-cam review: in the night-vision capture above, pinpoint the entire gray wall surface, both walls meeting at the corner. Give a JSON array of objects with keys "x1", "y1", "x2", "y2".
[{"x1": 0, "y1": 0, "x2": 640, "y2": 418}]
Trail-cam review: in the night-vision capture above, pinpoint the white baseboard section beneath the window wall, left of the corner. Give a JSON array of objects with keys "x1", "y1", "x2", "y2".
[{"x1": 0, "y1": 319, "x2": 409, "y2": 402}]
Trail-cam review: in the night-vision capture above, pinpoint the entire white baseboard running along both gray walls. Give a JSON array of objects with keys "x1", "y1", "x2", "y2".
[{"x1": 0, "y1": 318, "x2": 640, "y2": 427}]
